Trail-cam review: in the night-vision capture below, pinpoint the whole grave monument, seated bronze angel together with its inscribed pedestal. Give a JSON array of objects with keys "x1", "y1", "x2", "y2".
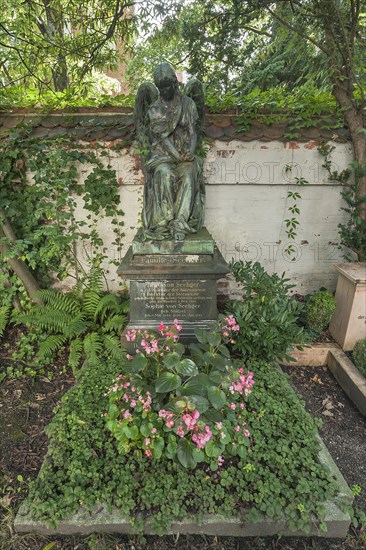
[{"x1": 118, "y1": 63, "x2": 229, "y2": 342}]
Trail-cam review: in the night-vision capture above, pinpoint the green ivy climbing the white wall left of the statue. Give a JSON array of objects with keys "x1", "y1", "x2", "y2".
[{"x1": 0, "y1": 132, "x2": 124, "y2": 291}]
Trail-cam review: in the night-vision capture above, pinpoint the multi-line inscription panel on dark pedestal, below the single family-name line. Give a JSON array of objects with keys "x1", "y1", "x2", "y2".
[{"x1": 131, "y1": 280, "x2": 216, "y2": 322}]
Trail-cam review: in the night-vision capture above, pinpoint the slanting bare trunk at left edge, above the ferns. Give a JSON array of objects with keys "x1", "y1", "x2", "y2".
[{"x1": 0, "y1": 209, "x2": 42, "y2": 304}]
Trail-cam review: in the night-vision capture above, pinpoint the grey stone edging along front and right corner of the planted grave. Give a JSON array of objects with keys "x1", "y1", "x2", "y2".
[{"x1": 14, "y1": 438, "x2": 353, "y2": 538}]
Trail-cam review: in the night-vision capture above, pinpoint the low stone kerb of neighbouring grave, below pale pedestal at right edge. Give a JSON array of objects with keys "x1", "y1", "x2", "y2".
[{"x1": 328, "y1": 349, "x2": 366, "y2": 416}]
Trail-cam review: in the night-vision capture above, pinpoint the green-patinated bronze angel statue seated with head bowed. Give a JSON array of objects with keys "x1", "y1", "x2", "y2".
[{"x1": 135, "y1": 63, "x2": 205, "y2": 241}]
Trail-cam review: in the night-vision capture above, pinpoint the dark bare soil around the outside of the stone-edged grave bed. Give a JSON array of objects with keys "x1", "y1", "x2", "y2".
[{"x1": 0, "y1": 333, "x2": 366, "y2": 550}]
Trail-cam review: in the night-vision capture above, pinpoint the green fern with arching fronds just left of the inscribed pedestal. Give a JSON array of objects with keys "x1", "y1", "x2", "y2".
[{"x1": 15, "y1": 272, "x2": 128, "y2": 373}]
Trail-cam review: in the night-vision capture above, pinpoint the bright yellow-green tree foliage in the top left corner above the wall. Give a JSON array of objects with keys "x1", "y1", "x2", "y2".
[{"x1": 0, "y1": 0, "x2": 135, "y2": 95}]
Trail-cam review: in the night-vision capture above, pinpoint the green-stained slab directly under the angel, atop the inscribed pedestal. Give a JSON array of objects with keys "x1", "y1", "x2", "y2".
[{"x1": 132, "y1": 227, "x2": 215, "y2": 255}]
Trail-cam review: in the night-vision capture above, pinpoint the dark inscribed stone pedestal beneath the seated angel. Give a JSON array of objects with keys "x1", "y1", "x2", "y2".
[{"x1": 117, "y1": 228, "x2": 229, "y2": 343}]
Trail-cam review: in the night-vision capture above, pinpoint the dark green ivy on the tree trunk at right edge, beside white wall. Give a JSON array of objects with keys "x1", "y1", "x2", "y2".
[{"x1": 318, "y1": 143, "x2": 366, "y2": 262}]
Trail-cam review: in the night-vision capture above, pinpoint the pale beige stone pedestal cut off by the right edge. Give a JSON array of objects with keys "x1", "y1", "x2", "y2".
[{"x1": 329, "y1": 262, "x2": 366, "y2": 351}]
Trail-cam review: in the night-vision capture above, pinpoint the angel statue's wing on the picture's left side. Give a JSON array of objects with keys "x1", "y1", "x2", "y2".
[{"x1": 134, "y1": 82, "x2": 159, "y2": 160}]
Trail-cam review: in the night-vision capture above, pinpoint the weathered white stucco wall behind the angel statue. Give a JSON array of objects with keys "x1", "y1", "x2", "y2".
[{"x1": 70, "y1": 140, "x2": 352, "y2": 294}]
